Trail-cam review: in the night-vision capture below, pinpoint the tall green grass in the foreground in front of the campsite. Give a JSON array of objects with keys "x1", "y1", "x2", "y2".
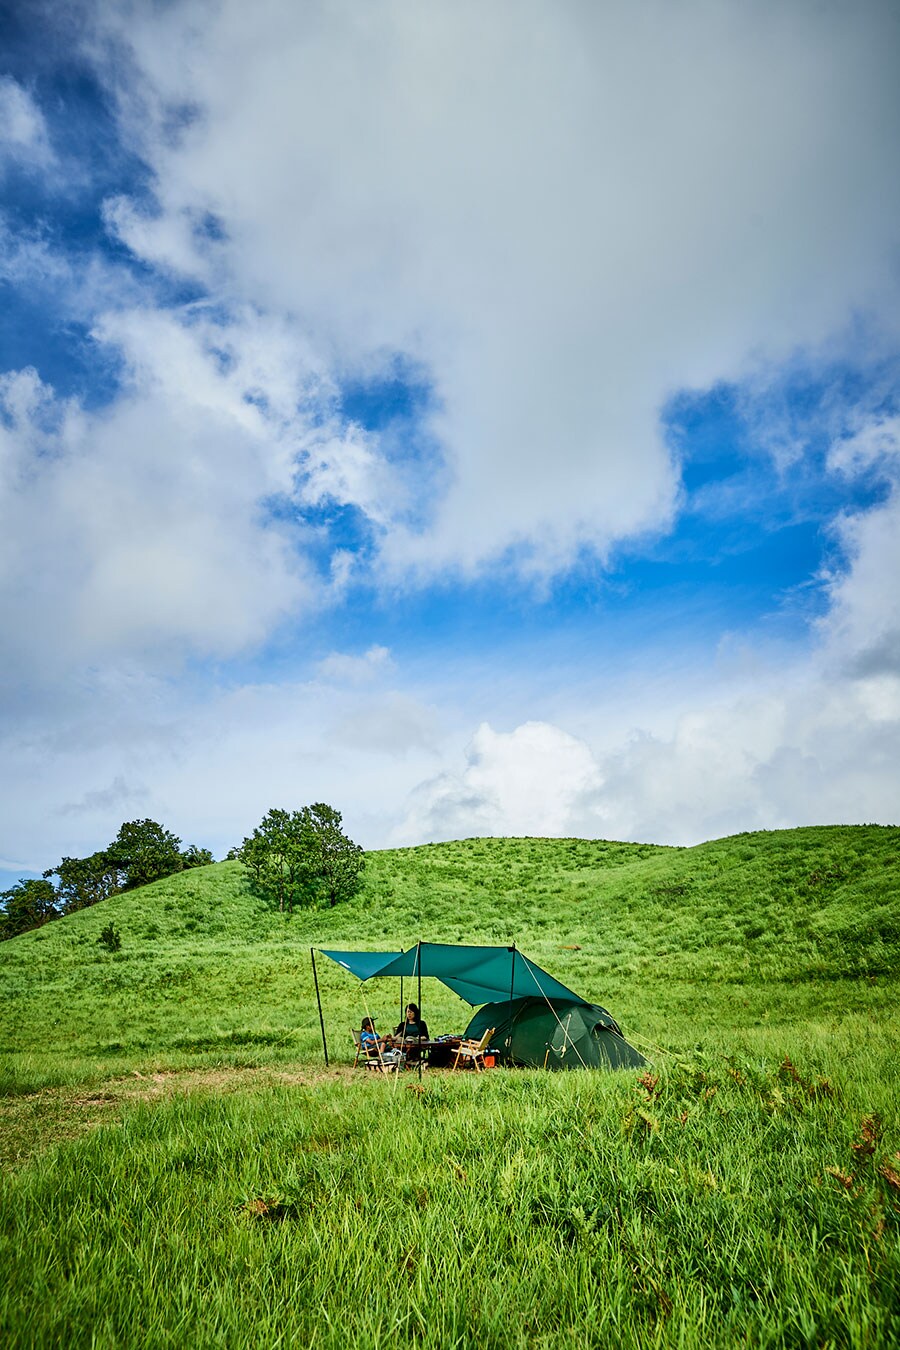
[{"x1": 0, "y1": 1046, "x2": 900, "y2": 1347}]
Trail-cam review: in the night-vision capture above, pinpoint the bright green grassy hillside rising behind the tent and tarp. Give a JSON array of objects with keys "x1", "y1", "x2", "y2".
[{"x1": 0, "y1": 826, "x2": 900, "y2": 1081}]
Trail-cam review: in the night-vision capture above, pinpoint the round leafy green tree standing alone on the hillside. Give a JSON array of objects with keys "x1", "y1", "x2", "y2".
[{"x1": 242, "y1": 802, "x2": 366, "y2": 914}]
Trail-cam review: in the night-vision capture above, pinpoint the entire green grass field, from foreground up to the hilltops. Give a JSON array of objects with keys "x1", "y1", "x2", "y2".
[{"x1": 0, "y1": 826, "x2": 900, "y2": 1347}]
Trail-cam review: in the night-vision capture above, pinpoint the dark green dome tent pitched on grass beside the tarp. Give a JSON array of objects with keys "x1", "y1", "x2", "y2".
[{"x1": 466, "y1": 996, "x2": 648, "y2": 1069}]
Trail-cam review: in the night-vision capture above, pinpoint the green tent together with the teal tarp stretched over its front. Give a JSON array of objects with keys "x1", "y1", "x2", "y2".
[{"x1": 313, "y1": 942, "x2": 646, "y2": 1069}]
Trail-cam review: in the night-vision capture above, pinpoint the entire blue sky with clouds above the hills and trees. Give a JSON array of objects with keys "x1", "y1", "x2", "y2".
[{"x1": 0, "y1": 0, "x2": 900, "y2": 883}]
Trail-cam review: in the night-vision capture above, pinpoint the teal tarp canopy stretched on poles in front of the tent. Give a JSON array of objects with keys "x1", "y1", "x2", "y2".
[{"x1": 320, "y1": 942, "x2": 590, "y2": 1007}]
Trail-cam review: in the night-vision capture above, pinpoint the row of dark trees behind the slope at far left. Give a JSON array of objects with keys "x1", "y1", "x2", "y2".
[{"x1": 0, "y1": 819, "x2": 215, "y2": 941}]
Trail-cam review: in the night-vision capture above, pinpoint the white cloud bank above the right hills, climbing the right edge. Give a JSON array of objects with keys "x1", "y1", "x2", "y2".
[{"x1": 398, "y1": 416, "x2": 900, "y2": 844}]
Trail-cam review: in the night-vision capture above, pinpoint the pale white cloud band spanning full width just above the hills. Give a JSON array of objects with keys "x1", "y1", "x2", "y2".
[{"x1": 0, "y1": 480, "x2": 900, "y2": 865}]
